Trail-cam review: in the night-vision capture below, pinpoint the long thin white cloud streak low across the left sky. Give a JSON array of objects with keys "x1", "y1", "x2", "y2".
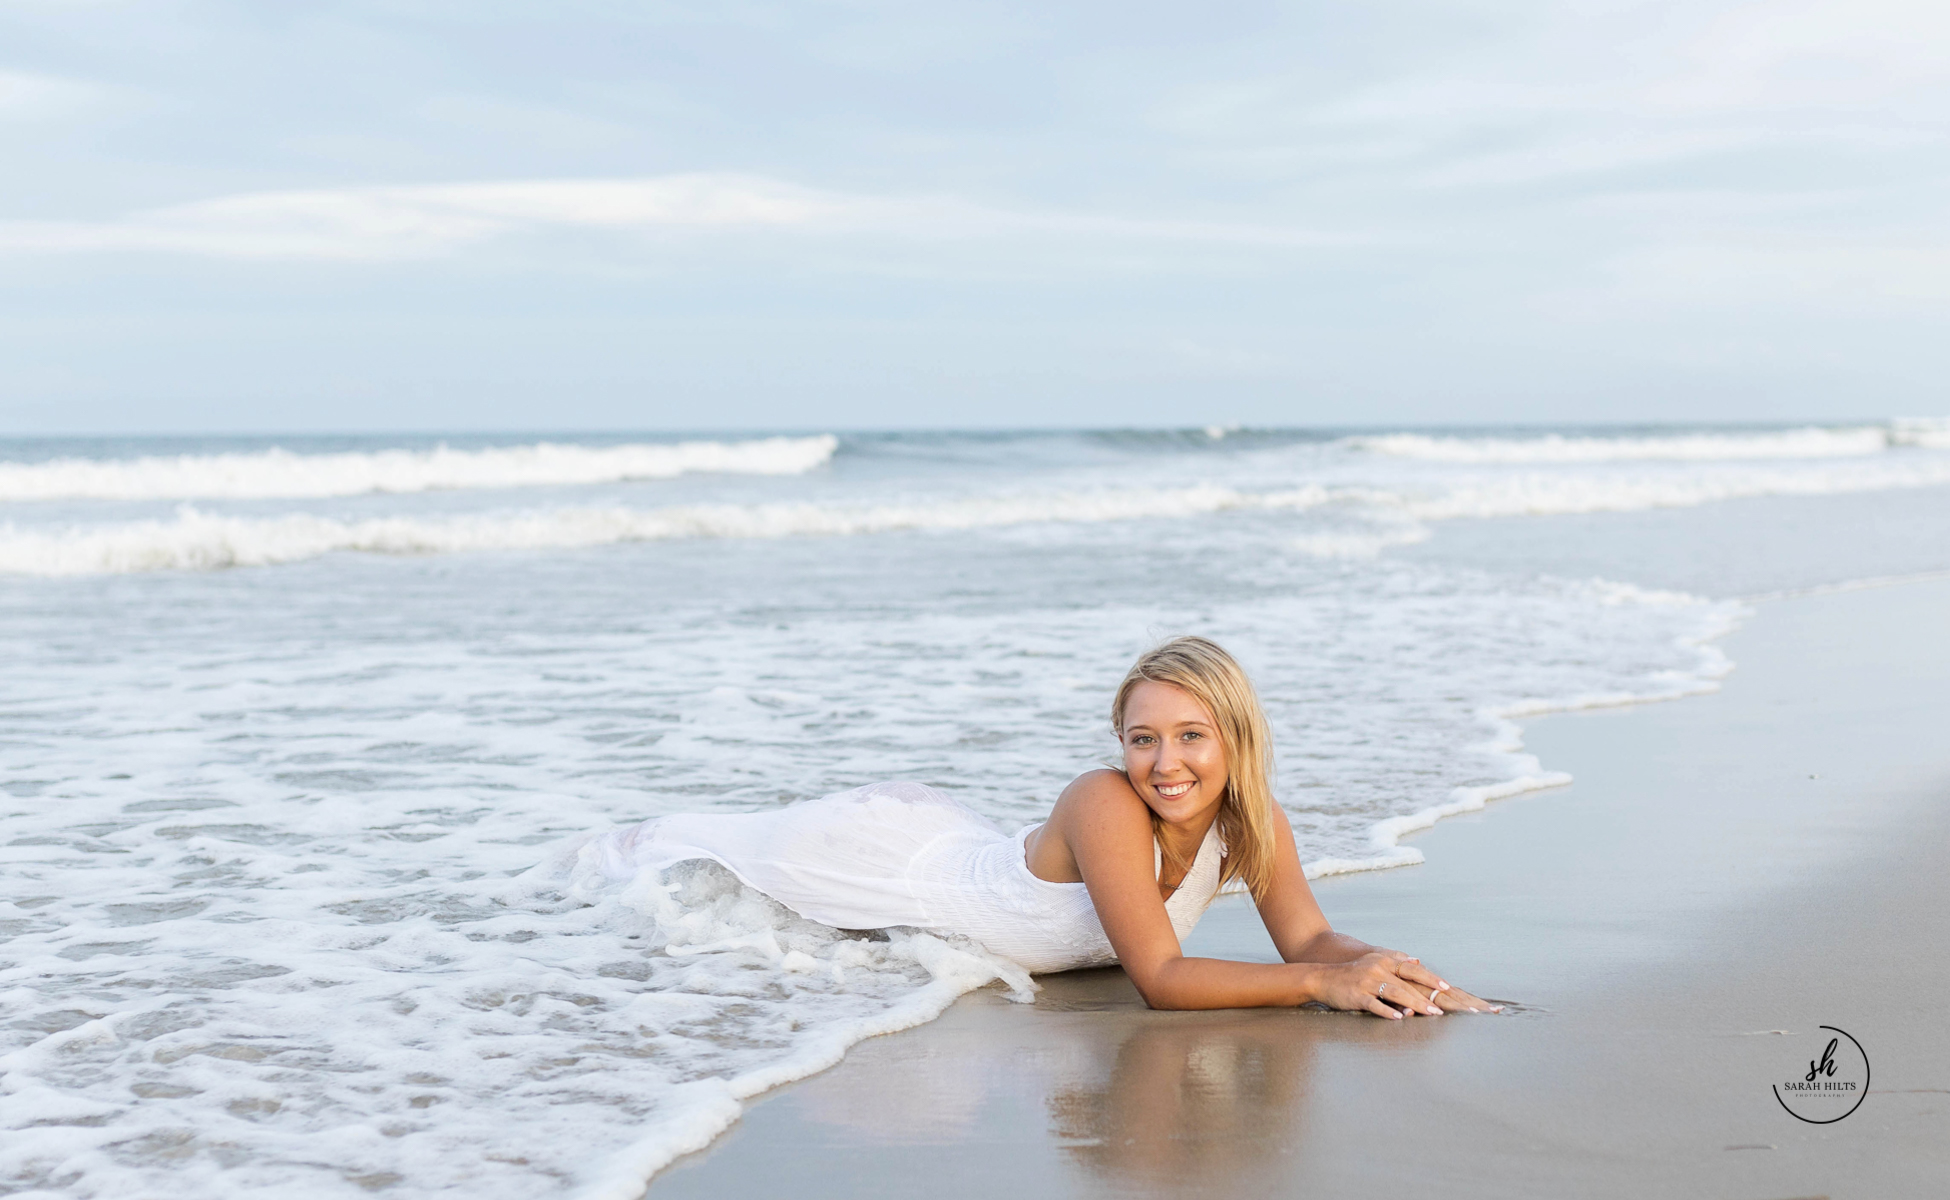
[{"x1": 0, "y1": 172, "x2": 1347, "y2": 260}]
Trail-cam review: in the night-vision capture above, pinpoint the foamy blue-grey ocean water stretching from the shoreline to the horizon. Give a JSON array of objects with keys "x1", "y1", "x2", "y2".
[{"x1": 0, "y1": 420, "x2": 1950, "y2": 1200}]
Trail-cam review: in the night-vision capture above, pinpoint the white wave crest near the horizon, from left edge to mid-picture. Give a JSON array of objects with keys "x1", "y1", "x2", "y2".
[{"x1": 0, "y1": 435, "x2": 839, "y2": 501}]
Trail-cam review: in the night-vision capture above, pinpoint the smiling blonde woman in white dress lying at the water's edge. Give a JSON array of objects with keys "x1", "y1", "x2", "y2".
[{"x1": 581, "y1": 638, "x2": 1496, "y2": 1019}]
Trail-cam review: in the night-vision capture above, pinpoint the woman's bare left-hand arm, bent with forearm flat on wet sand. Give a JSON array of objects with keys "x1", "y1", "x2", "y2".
[{"x1": 1051, "y1": 771, "x2": 1435, "y2": 1017}]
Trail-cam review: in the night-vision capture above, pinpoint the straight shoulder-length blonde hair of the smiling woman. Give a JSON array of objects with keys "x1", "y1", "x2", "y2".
[{"x1": 1110, "y1": 638, "x2": 1275, "y2": 900}]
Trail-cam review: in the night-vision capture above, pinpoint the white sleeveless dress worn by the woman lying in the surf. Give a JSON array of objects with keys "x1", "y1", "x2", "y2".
[{"x1": 579, "y1": 782, "x2": 1225, "y2": 974}]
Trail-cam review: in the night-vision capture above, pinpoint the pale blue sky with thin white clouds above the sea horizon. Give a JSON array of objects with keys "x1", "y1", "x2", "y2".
[{"x1": 0, "y1": 0, "x2": 1950, "y2": 435}]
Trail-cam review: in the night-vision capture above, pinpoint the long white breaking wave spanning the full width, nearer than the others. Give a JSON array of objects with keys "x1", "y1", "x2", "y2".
[{"x1": 11, "y1": 442, "x2": 1950, "y2": 576}]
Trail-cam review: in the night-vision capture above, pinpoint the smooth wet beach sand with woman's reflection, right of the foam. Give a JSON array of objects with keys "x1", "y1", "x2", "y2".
[{"x1": 649, "y1": 580, "x2": 1950, "y2": 1200}]
